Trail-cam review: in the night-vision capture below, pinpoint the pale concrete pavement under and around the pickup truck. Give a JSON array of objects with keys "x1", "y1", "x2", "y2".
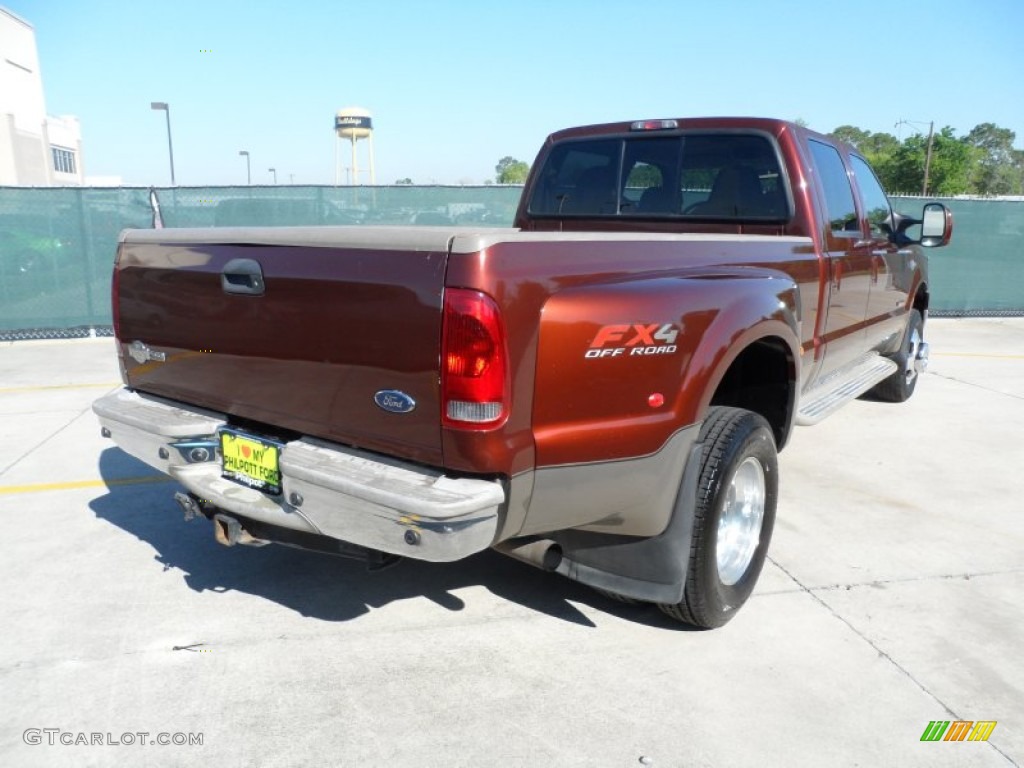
[{"x1": 0, "y1": 318, "x2": 1024, "y2": 768}]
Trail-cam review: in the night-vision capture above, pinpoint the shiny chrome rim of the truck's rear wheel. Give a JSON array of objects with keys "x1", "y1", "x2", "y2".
[{"x1": 716, "y1": 457, "x2": 765, "y2": 587}]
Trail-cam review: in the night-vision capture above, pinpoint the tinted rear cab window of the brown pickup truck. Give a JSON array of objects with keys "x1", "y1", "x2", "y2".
[{"x1": 527, "y1": 131, "x2": 792, "y2": 222}]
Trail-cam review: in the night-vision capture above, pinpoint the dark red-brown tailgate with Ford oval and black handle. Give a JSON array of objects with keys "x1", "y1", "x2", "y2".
[{"x1": 117, "y1": 227, "x2": 452, "y2": 464}]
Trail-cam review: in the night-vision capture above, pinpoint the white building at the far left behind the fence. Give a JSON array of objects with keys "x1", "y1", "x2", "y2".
[{"x1": 0, "y1": 7, "x2": 84, "y2": 186}]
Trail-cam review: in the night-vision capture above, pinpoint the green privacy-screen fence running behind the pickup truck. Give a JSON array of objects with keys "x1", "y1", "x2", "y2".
[{"x1": 0, "y1": 186, "x2": 1024, "y2": 339}]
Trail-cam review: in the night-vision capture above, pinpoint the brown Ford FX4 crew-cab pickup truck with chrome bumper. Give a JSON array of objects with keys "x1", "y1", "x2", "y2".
[{"x1": 94, "y1": 118, "x2": 952, "y2": 627}]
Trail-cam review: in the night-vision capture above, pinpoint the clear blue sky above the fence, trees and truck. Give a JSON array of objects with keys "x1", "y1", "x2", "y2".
[{"x1": 8, "y1": 0, "x2": 1024, "y2": 185}]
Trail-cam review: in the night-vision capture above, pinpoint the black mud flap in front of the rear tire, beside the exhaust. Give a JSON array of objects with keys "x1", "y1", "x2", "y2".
[{"x1": 551, "y1": 442, "x2": 703, "y2": 603}]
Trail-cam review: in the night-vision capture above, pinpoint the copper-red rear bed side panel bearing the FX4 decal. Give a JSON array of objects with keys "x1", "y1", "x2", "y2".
[{"x1": 444, "y1": 239, "x2": 819, "y2": 471}]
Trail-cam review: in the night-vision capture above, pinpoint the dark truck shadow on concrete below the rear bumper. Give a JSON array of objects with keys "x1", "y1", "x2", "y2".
[{"x1": 89, "y1": 447, "x2": 690, "y2": 631}]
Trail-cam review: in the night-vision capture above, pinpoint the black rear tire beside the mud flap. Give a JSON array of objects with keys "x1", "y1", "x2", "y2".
[{"x1": 658, "y1": 407, "x2": 778, "y2": 629}]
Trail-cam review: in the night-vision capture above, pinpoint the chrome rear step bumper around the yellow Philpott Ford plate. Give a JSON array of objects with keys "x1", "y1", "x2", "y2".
[{"x1": 93, "y1": 389, "x2": 505, "y2": 562}]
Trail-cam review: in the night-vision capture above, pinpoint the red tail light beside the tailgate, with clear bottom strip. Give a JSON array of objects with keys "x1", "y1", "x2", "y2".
[{"x1": 441, "y1": 288, "x2": 508, "y2": 428}]
